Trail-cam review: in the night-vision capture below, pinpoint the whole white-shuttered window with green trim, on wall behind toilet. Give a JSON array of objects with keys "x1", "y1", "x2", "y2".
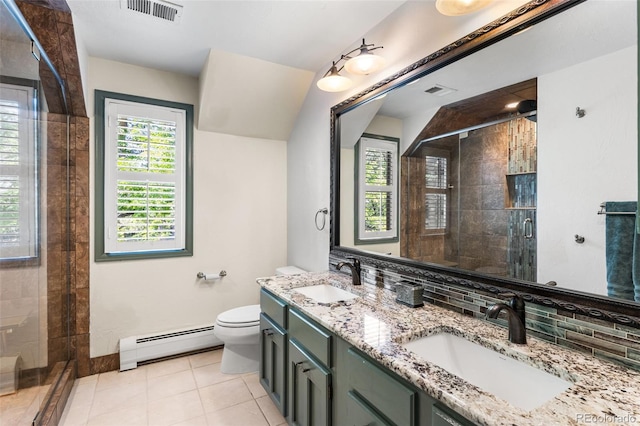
[{"x1": 96, "y1": 90, "x2": 193, "y2": 261}]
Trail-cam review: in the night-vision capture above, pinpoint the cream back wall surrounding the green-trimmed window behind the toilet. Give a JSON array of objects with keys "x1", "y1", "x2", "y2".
[{"x1": 87, "y1": 58, "x2": 288, "y2": 357}]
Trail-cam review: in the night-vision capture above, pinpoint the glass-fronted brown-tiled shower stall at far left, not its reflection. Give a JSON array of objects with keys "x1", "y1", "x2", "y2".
[{"x1": 0, "y1": 0, "x2": 75, "y2": 426}]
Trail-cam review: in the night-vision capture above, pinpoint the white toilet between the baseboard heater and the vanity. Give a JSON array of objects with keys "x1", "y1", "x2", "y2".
[{"x1": 213, "y1": 266, "x2": 305, "y2": 374}]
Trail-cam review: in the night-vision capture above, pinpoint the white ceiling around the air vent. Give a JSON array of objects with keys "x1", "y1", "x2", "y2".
[{"x1": 67, "y1": 0, "x2": 408, "y2": 76}]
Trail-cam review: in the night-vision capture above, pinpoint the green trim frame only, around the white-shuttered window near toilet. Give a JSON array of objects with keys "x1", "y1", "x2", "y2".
[{"x1": 95, "y1": 90, "x2": 194, "y2": 262}]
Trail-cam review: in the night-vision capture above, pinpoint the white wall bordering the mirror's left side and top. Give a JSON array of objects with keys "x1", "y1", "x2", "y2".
[{"x1": 287, "y1": 0, "x2": 525, "y2": 271}]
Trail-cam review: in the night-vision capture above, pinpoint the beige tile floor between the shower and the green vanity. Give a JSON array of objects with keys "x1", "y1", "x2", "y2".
[{"x1": 60, "y1": 350, "x2": 286, "y2": 426}]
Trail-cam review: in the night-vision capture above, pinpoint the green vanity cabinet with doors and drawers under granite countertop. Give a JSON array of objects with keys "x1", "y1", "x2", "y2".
[{"x1": 260, "y1": 289, "x2": 474, "y2": 426}]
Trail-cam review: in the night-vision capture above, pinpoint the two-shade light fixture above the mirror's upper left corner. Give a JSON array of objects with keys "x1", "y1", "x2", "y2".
[{"x1": 316, "y1": 39, "x2": 385, "y2": 92}]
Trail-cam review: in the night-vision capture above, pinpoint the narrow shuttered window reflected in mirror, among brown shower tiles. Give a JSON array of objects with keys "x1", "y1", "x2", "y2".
[{"x1": 424, "y1": 155, "x2": 448, "y2": 234}]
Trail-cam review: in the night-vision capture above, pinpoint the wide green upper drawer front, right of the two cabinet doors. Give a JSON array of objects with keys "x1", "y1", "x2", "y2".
[{"x1": 347, "y1": 348, "x2": 418, "y2": 426}]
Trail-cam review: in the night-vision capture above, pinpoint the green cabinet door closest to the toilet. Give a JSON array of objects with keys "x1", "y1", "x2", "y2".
[{"x1": 260, "y1": 314, "x2": 287, "y2": 416}]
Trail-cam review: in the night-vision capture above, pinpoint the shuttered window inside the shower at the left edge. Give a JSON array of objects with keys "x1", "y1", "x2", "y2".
[{"x1": 0, "y1": 79, "x2": 39, "y2": 263}]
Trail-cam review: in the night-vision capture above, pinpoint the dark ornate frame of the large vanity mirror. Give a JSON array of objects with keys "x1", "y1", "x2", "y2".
[{"x1": 330, "y1": 0, "x2": 640, "y2": 328}]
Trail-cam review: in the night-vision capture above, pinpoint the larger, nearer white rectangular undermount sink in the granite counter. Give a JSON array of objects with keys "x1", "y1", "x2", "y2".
[{"x1": 401, "y1": 333, "x2": 572, "y2": 411}]
